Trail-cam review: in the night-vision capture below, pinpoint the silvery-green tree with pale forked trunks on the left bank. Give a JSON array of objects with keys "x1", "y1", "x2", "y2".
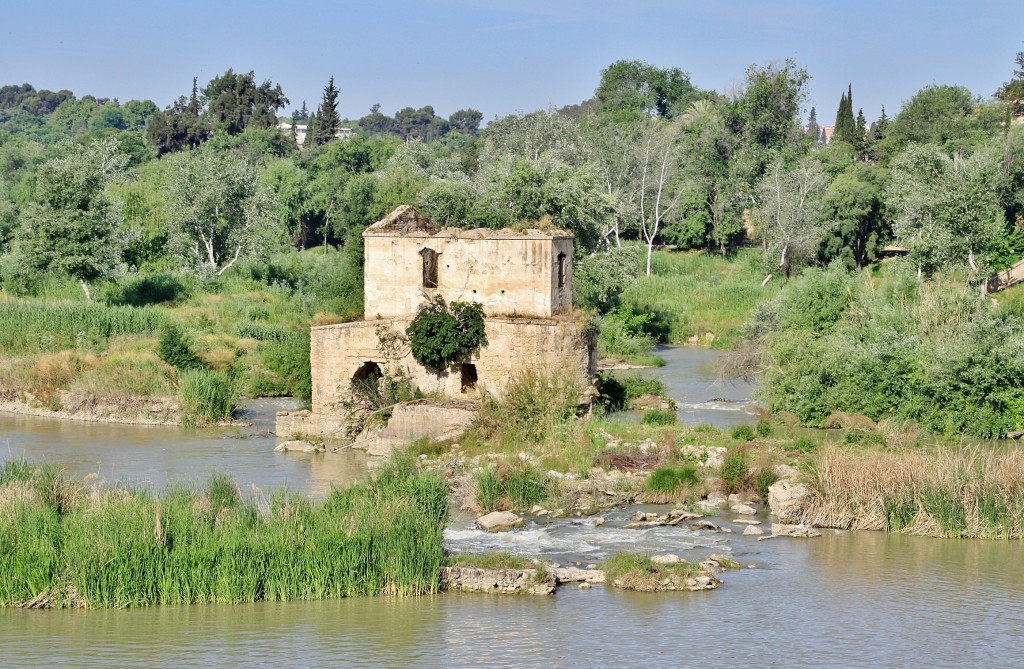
[{"x1": 165, "y1": 149, "x2": 284, "y2": 275}]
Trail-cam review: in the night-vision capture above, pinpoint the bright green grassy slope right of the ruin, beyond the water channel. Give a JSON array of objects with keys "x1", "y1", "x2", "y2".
[{"x1": 623, "y1": 249, "x2": 782, "y2": 348}]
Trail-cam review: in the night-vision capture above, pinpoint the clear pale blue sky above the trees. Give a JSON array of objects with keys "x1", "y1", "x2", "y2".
[{"x1": 0, "y1": 0, "x2": 1024, "y2": 124}]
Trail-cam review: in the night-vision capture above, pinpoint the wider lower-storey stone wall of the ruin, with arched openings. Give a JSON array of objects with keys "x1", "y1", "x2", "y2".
[{"x1": 310, "y1": 318, "x2": 597, "y2": 414}]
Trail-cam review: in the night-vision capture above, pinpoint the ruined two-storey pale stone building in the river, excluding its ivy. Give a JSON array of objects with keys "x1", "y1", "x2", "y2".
[{"x1": 278, "y1": 206, "x2": 596, "y2": 438}]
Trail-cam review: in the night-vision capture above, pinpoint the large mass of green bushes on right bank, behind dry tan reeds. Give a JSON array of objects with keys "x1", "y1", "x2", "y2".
[{"x1": 751, "y1": 269, "x2": 1024, "y2": 437}]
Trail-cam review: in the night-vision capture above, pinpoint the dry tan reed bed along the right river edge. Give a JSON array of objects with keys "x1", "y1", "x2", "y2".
[{"x1": 803, "y1": 446, "x2": 1024, "y2": 539}]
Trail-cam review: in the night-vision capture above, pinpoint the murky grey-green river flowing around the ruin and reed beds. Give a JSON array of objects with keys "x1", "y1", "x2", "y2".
[{"x1": 0, "y1": 348, "x2": 1024, "y2": 667}]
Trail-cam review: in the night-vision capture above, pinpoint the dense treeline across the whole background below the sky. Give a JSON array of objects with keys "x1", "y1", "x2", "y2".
[{"x1": 0, "y1": 53, "x2": 1024, "y2": 306}]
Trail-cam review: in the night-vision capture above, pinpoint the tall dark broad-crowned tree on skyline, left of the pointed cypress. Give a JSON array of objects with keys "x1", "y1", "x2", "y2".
[{"x1": 203, "y1": 69, "x2": 288, "y2": 135}]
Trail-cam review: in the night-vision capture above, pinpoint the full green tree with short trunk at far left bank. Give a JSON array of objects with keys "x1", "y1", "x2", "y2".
[{"x1": 17, "y1": 139, "x2": 128, "y2": 299}]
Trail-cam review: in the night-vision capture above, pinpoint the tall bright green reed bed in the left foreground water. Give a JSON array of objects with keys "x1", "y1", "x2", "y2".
[{"x1": 0, "y1": 459, "x2": 447, "y2": 608}]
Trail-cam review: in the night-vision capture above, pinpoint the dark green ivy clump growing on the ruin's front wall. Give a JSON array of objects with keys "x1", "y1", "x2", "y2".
[{"x1": 406, "y1": 295, "x2": 487, "y2": 371}]
